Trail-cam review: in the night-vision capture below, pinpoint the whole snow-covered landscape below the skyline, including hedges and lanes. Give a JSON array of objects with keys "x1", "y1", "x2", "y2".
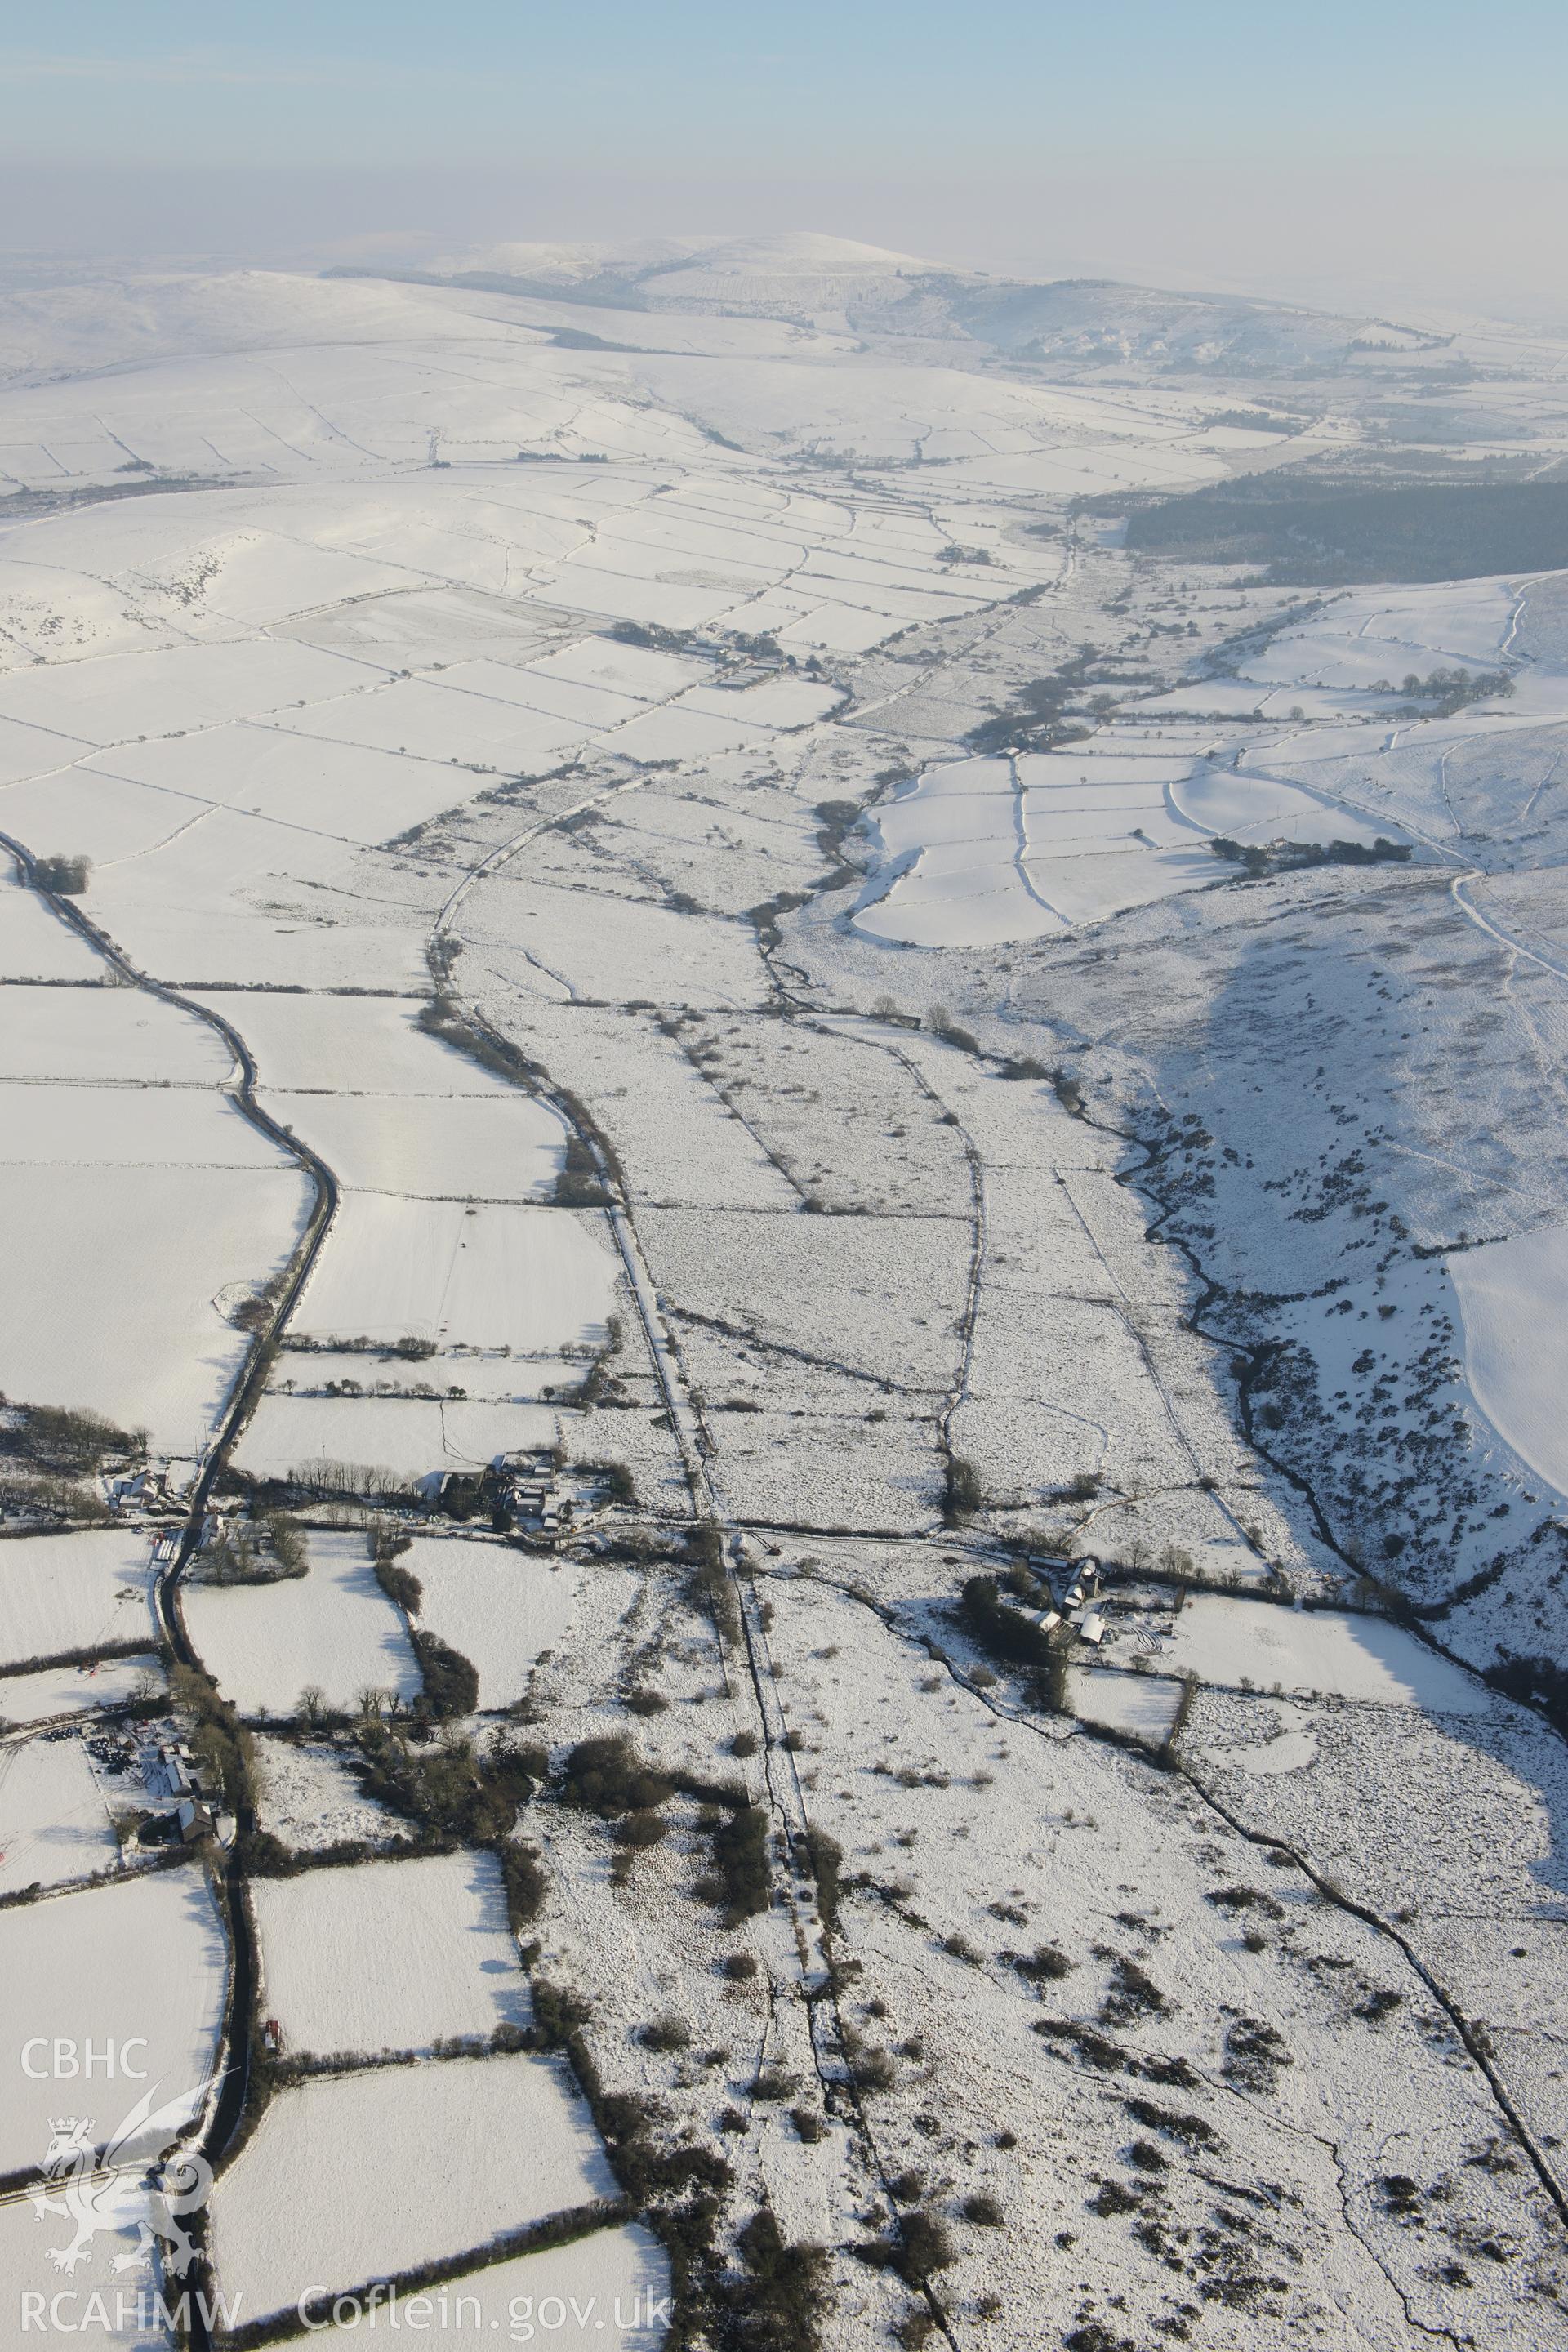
[{"x1": 0, "y1": 238, "x2": 1568, "y2": 2352}]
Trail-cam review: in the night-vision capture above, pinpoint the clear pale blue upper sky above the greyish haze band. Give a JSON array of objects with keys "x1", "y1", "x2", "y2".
[{"x1": 0, "y1": 0, "x2": 1568, "y2": 176}]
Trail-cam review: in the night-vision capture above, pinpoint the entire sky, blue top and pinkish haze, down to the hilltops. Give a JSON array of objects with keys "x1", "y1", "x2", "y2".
[{"x1": 0, "y1": 0, "x2": 1568, "y2": 318}]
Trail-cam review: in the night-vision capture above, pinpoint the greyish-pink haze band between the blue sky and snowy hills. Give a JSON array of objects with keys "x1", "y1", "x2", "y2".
[{"x1": 0, "y1": 165, "x2": 1568, "y2": 327}]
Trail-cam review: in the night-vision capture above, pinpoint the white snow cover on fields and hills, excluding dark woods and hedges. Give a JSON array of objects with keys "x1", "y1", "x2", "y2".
[{"x1": 0, "y1": 257, "x2": 1568, "y2": 2352}]
